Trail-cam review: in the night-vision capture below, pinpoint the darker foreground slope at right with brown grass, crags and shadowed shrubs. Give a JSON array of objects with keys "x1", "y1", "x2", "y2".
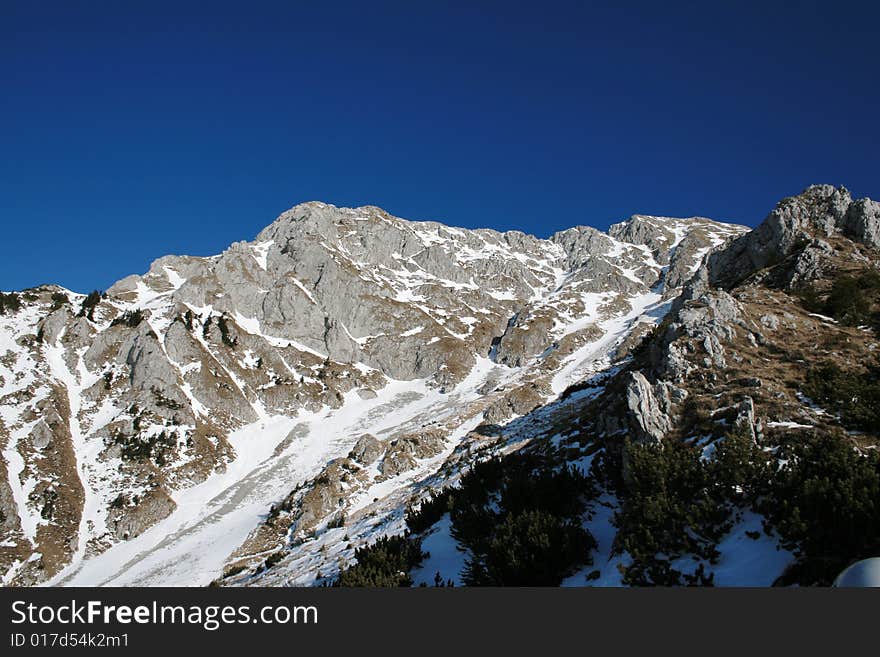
[{"x1": 276, "y1": 186, "x2": 880, "y2": 585}]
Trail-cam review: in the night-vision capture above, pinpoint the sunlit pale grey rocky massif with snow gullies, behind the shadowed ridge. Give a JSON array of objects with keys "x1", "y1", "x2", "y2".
[{"x1": 0, "y1": 197, "x2": 748, "y2": 584}]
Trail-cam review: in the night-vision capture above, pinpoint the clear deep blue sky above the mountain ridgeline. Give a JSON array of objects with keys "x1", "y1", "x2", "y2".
[{"x1": 0, "y1": 0, "x2": 880, "y2": 291}]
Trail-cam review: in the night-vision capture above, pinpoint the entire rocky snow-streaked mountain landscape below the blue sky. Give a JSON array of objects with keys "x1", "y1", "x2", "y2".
[{"x1": 0, "y1": 186, "x2": 880, "y2": 586}]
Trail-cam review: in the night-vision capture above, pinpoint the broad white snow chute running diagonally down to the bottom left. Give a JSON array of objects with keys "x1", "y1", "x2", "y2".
[{"x1": 49, "y1": 374, "x2": 488, "y2": 586}]
